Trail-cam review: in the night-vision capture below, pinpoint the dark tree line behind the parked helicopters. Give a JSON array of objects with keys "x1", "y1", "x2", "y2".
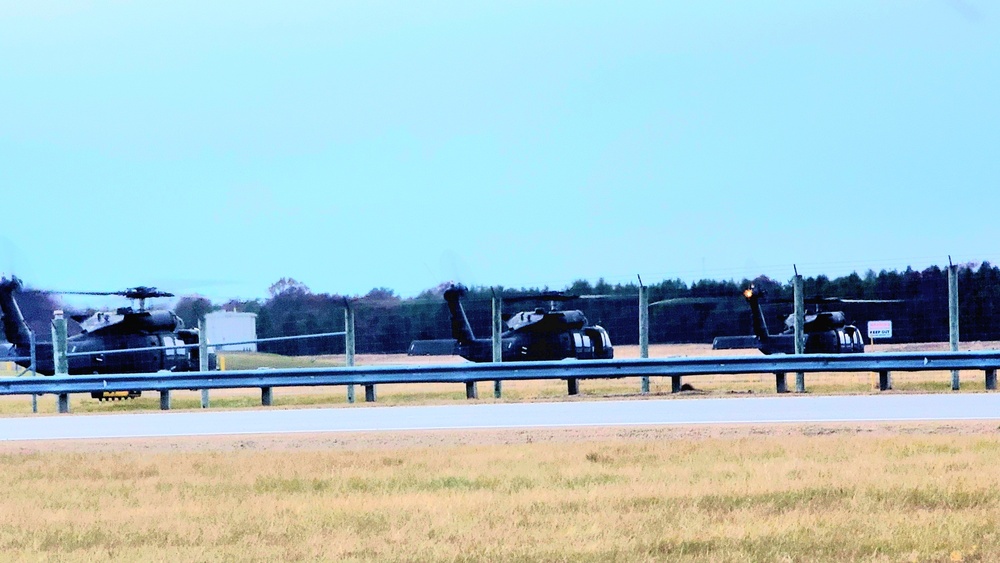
[{"x1": 168, "y1": 262, "x2": 1000, "y2": 355}]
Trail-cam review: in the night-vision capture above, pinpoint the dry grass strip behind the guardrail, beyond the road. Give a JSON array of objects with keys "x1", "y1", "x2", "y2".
[{"x1": 0, "y1": 342, "x2": 1000, "y2": 415}]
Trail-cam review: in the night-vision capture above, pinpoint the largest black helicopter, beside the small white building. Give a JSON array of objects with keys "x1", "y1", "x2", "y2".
[{"x1": 0, "y1": 277, "x2": 214, "y2": 399}]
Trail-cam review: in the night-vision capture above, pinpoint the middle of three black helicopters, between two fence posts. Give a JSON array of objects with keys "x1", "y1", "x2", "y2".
[{"x1": 444, "y1": 285, "x2": 615, "y2": 362}]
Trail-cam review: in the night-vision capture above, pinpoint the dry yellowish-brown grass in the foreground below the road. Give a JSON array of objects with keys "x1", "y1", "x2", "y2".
[{"x1": 0, "y1": 425, "x2": 1000, "y2": 561}]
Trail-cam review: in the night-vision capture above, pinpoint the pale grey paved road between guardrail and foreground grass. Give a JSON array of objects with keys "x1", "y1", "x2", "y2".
[{"x1": 0, "y1": 394, "x2": 1000, "y2": 441}]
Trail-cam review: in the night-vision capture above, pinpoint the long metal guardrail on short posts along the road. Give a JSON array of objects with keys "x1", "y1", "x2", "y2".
[{"x1": 0, "y1": 351, "x2": 1000, "y2": 412}]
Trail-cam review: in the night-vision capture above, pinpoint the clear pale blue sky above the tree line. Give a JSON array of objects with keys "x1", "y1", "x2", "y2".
[{"x1": 0, "y1": 0, "x2": 1000, "y2": 303}]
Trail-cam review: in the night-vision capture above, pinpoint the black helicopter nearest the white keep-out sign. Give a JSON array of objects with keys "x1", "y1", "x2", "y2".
[{"x1": 743, "y1": 287, "x2": 899, "y2": 354}]
